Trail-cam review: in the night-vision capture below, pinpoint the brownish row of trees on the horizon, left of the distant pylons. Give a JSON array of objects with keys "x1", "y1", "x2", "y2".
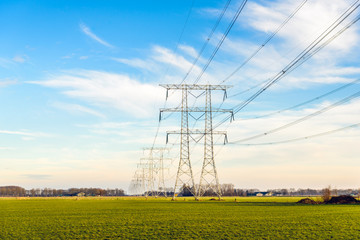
[{"x1": 0, "y1": 186, "x2": 125, "y2": 197}]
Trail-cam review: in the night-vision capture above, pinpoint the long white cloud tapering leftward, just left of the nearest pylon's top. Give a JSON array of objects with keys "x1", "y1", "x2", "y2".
[{"x1": 29, "y1": 70, "x2": 164, "y2": 118}]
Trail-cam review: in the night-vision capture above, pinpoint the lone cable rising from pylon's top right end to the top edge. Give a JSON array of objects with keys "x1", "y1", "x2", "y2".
[{"x1": 220, "y1": 0, "x2": 307, "y2": 84}]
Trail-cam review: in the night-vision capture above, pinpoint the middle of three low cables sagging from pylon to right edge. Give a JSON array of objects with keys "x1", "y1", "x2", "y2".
[{"x1": 232, "y1": 91, "x2": 360, "y2": 143}]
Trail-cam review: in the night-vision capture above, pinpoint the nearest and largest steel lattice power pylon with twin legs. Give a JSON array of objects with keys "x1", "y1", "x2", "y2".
[{"x1": 160, "y1": 84, "x2": 233, "y2": 199}]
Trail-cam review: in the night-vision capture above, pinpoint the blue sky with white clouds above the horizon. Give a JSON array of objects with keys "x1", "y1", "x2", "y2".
[{"x1": 0, "y1": 0, "x2": 360, "y2": 190}]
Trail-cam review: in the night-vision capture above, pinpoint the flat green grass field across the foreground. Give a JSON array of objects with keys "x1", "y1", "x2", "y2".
[{"x1": 0, "y1": 197, "x2": 360, "y2": 239}]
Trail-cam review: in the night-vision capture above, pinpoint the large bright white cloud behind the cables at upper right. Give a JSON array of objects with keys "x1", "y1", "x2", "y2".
[{"x1": 209, "y1": 0, "x2": 359, "y2": 88}]
